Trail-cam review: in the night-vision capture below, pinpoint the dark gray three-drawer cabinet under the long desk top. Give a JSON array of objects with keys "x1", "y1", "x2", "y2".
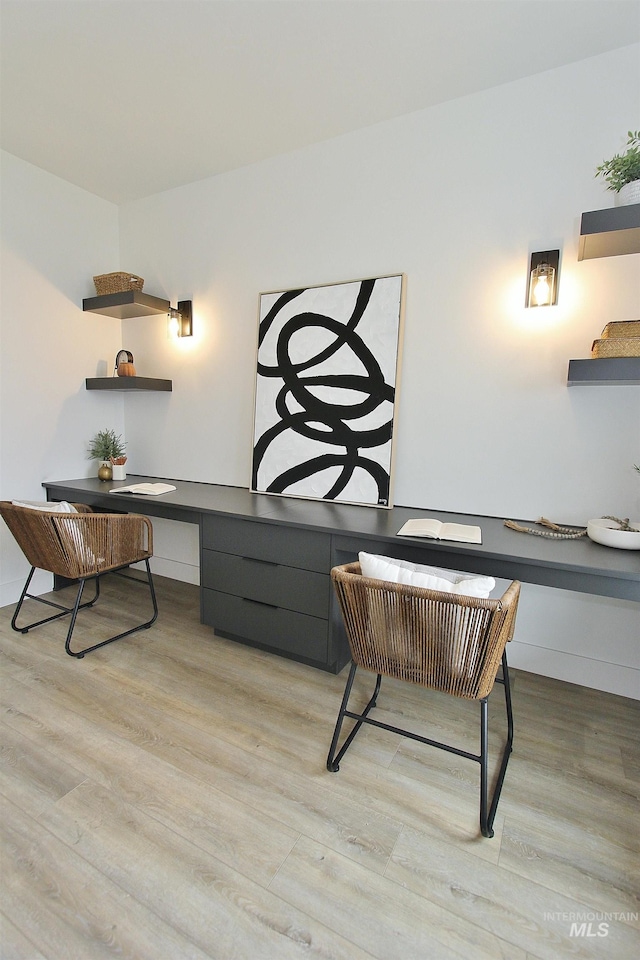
[{"x1": 200, "y1": 516, "x2": 340, "y2": 670}]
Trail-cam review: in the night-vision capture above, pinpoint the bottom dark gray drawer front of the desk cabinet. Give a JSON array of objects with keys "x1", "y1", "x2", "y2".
[{"x1": 202, "y1": 589, "x2": 328, "y2": 663}]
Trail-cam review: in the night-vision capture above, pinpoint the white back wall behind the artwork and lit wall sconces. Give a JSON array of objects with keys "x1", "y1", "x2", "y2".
[{"x1": 3, "y1": 46, "x2": 640, "y2": 697}]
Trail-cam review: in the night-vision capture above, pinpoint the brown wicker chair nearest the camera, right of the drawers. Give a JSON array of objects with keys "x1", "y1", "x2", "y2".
[{"x1": 327, "y1": 563, "x2": 520, "y2": 837}]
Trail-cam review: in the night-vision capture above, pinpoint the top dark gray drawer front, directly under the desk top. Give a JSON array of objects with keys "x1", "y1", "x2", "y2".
[{"x1": 202, "y1": 516, "x2": 331, "y2": 573}]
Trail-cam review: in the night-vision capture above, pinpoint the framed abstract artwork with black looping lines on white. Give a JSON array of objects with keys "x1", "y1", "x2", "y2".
[{"x1": 251, "y1": 274, "x2": 404, "y2": 507}]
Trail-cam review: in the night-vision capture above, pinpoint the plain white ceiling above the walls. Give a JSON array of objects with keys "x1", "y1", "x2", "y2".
[{"x1": 0, "y1": 0, "x2": 640, "y2": 203}]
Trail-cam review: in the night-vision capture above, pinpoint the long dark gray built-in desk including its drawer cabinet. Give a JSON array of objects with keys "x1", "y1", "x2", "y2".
[{"x1": 43, "y1": 476, "x2": 640, "y2": 672}]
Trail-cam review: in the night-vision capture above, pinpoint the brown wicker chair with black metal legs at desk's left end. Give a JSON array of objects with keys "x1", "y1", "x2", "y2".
[{"x1": 0, "y1": 501, "x2": 158, "y2": 658}]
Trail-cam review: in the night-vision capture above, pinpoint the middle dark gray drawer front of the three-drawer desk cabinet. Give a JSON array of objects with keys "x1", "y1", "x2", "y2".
[{"x1": 201, "y1": 550, "x2": 331, "y2": 620}]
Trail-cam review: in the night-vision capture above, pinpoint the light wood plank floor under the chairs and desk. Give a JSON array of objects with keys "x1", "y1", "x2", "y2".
[{"x1": 0, "y1": 578, "x2": 640, "y2": 960}]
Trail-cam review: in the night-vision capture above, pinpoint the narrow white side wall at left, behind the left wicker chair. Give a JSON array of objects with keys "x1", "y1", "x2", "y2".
[{"x1": 0, "y1": 152, "x2": 124, "y2": 604}]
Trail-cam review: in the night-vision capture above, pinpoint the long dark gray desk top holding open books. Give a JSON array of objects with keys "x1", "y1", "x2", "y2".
[{"x1": 43, "y1": 476, "x2": 640, "y2": 602}]
